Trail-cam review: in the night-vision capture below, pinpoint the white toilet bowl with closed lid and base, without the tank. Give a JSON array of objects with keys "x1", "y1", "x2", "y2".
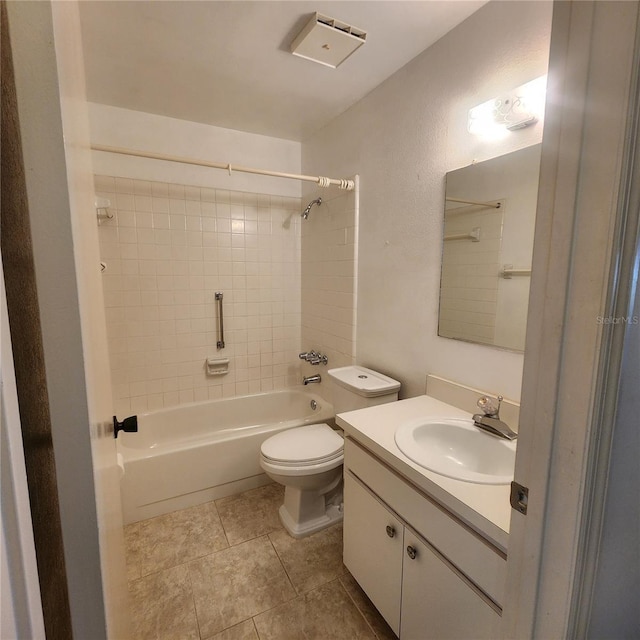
[{"x1": 260, "y1": 423, "x2": 344, "y2": 538}]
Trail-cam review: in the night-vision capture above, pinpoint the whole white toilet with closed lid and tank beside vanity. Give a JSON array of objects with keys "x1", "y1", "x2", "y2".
[{"x1": 260, "y1": 366, "x2": 400, "y2": 538}]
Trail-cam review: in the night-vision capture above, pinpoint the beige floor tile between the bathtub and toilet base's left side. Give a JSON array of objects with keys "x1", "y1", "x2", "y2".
[{"x1": 216, "y1": 483, "x2": 284, "y2": 545}]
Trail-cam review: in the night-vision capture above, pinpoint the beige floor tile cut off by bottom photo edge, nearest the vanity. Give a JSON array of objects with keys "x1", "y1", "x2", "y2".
[{"x1": 254, "y1": 580, "x2": 375, "y2": 640}]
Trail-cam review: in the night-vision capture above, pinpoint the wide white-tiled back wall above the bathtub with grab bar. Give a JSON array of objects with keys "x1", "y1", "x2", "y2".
[{"x1": 95, "y1": 175, "x2": 301, "y2": 414}]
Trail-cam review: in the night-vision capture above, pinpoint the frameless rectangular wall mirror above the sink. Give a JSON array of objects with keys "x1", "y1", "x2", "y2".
[{"x1": 438, "y1": 144, "x2": 540, "y2": 351}]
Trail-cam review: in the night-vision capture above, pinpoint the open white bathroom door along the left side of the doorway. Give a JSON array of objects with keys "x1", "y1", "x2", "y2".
[{"x1": 6, "y1": 0, "x2": 130, "y2": 640}]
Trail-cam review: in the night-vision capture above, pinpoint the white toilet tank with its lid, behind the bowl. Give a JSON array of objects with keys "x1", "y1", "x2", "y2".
[{"x1": 327, "y1": 365, "x2": 400, "y2": 413}]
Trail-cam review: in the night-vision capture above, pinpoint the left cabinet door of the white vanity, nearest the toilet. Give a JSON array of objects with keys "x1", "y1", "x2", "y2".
[{"x1": 344, "y1": 471, "x2": 404, "y2": 635}]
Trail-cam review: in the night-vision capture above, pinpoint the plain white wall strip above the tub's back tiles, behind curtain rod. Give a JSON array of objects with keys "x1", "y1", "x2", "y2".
[{"x1": 89, "y1": 103, "x2": 302, "y2": 198}]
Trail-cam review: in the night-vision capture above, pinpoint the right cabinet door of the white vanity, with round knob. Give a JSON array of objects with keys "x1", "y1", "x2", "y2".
[{"x1": 400, "y1": 529, "x2": 502, "y2": 640}]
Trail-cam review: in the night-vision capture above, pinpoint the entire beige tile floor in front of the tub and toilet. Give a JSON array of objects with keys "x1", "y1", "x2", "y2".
[{"x1": 125, "y1": 484, "x2": 396, "y2": 640}]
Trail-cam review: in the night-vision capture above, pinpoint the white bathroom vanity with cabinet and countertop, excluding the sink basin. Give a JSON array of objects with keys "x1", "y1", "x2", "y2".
[{"x1": 337, "y1": 396, "x2": 510, "y2": 640}]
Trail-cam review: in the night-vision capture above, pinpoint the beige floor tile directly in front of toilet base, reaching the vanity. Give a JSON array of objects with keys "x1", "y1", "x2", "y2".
[{"x1": 269, "y1": 524, "x2": 346, "y2": 594}]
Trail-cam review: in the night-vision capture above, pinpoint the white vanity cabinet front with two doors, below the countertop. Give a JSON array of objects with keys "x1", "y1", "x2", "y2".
[{"x1": 344, "y1": 438, "x2": 506, "y2": 640}]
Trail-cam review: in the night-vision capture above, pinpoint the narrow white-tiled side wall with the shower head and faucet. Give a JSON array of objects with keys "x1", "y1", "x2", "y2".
[{"x1": 301, "y1": 187, "x2": 358, "y2": 373}]
